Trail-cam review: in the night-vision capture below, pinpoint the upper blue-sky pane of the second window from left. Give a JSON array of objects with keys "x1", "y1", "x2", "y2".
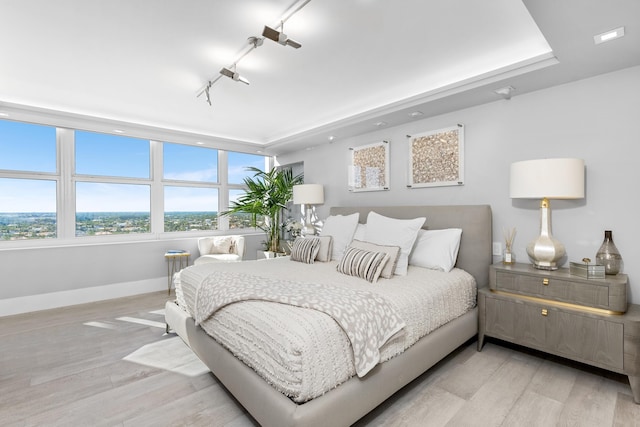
[{"x1": 75, "y1": 131, "x2": 151, "y2": 179}]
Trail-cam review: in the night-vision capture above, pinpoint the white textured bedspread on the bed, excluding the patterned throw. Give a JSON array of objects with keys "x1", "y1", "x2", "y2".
[{"x1": 175, "y1": 257, "x2": 476, "y2": 402}]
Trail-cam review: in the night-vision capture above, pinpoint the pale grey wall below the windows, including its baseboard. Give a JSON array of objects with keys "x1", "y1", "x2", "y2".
[{"x1": 0, "y1": 234, "x2": 264, "y2": 316}]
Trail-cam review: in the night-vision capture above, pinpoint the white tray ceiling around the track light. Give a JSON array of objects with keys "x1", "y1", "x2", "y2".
[{"x1": 0, "y1": 0, "x2": 640, "y2": 153}]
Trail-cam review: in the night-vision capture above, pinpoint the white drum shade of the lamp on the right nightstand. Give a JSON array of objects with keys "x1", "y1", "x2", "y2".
[{"x1": 509, "y1": 159, "x2": 584, "y2": 199}]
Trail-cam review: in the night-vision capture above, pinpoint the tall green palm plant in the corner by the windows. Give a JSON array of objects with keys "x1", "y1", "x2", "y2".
[{"x1": 220, "y1": 167, "x2": 303, "y2": 253}]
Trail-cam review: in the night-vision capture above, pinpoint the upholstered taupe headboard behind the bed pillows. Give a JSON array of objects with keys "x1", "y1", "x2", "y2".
[{"x1": 330, "y1": 205, "x2": 493, "y2": 287}]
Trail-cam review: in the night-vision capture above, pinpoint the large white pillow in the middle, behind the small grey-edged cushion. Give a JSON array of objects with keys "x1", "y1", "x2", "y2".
[{"x1": 364, "y1": 211, "x2": 426, "y2": 276}]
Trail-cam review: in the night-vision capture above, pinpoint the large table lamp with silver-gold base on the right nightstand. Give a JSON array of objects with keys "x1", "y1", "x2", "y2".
[{"x1": 509, "y1": 159, "x2": 584, "y2": 270}]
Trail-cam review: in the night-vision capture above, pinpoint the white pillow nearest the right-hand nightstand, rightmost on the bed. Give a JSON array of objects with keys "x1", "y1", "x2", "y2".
[{"x1": 409, "y1": 228, "x2": 462, "y2": 273}]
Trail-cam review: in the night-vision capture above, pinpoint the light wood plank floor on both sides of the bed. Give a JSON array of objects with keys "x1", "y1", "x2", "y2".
[{"x1": 0, "y1": 292, "x2": 640, "y2": 427}]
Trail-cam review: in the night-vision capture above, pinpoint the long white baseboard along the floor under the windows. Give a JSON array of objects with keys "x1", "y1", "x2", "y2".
[{"x1": 0, "y1": 277, "x2": 167, "y2": 317}]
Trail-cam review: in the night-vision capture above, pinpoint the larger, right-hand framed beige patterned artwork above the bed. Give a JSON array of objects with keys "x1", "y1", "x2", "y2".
[{"x1": 407, "y1": 125, "x2": 464, "y2": 188}]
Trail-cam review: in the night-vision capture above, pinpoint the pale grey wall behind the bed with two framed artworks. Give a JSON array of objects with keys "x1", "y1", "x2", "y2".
[{"x1": 278, "y1": 67, "x2": 640, "y2": 304}]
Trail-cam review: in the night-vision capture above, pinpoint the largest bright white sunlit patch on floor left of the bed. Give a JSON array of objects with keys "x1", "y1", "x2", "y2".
[{"x1": 123, "y1": 337, "x2": 209, "y2": 377}]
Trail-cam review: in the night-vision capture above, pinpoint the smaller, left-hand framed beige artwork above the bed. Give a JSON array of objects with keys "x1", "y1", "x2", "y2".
[{"x1": 349, "y1": 141, "x2": 389, "y2": 192}]
